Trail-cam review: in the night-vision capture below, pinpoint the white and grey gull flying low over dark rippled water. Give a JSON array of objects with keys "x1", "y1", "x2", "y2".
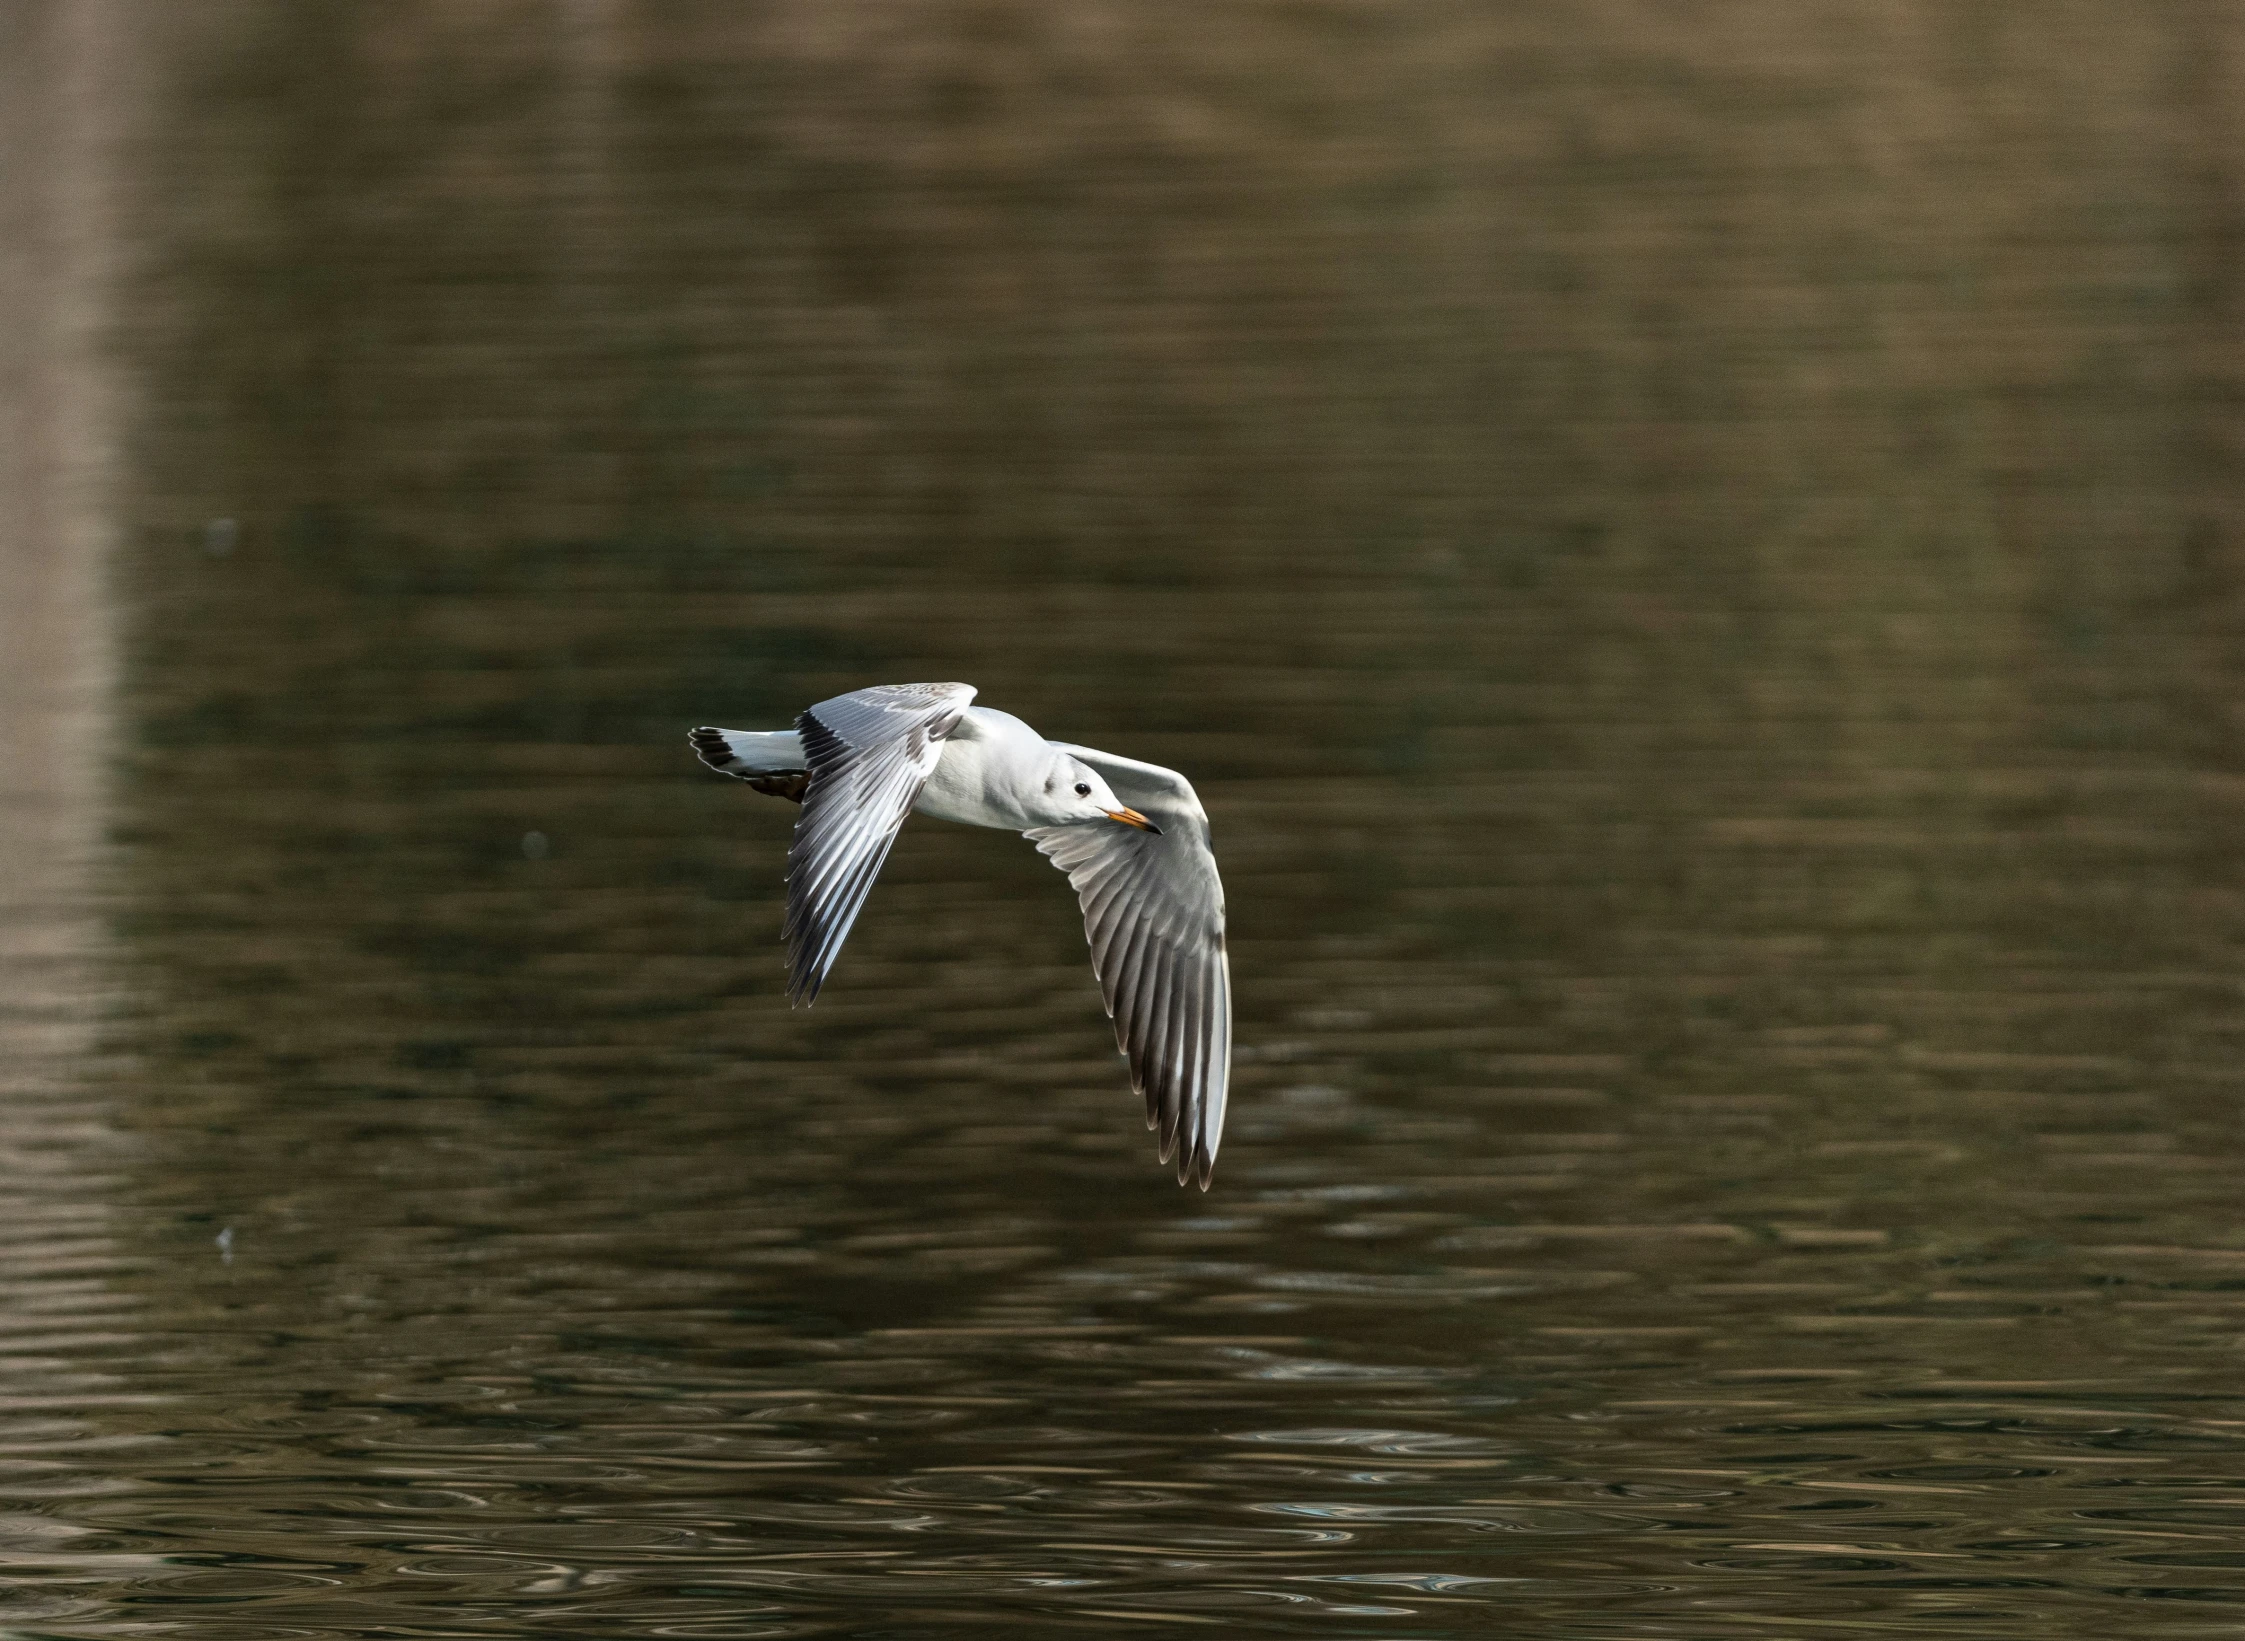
[{"x1": 687, "y1": 685, "x2": 1233, "y2": 1190}]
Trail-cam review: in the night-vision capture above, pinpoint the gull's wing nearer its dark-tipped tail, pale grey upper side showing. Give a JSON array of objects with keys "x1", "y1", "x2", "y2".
[{"x1": 788, "y1": 685, "x2": 974, "y2": 1003}]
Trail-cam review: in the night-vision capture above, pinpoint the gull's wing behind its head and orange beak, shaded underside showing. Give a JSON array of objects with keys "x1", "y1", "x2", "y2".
[{"x1": 1024, "y1": 745, "x2": 1233, "y2": 1190}]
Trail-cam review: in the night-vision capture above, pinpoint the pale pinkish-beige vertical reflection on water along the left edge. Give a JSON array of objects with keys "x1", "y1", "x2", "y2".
[{"x1": 0, "y1": 4, "x2": 168, "y2": 1634}]
